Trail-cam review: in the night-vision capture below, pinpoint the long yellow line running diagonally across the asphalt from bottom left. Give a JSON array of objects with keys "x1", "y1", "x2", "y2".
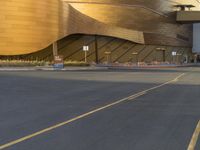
[{"x1": 0, "y1": 73, "x2": 185, "y2": 150}]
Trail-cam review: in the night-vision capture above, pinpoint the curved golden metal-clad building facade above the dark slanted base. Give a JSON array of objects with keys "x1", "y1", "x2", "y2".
[{"x1": 0, "y1": 0, "x2": 199, "y2": 55}]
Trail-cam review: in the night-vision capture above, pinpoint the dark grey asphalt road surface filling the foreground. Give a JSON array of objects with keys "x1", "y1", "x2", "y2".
[{"x1": 0, "y1": 68, "x2": 200, "y2": 150}]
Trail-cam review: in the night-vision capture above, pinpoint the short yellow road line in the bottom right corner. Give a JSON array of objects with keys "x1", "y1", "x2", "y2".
[{"x1": 187, "y1": 120, "x2": 200, "y2": 150}]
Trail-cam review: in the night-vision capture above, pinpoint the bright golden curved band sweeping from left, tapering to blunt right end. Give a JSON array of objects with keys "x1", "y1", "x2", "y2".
[{"x1": 0, "y1": 0, "x2": 144, "y2": 55}]
